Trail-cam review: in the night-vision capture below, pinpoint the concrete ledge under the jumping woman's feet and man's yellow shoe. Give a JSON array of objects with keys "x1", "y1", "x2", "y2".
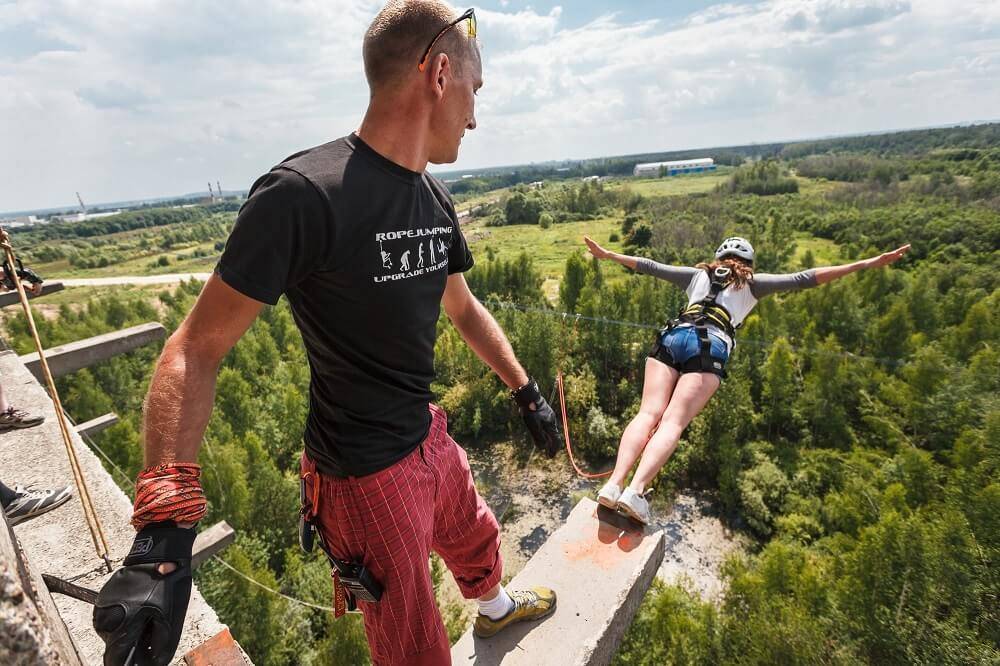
[{"x1": 451, "y1": 499, "x2": 664, "y2": 666}]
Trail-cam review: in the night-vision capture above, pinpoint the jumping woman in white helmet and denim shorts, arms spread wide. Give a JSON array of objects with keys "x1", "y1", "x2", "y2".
[{"x1": 584, "y1": 236, "x2": 910, "y2": 523}]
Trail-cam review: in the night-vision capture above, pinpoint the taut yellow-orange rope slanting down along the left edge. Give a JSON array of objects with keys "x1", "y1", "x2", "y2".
[{"x1": 0, "y1": 227, "x2": 112, "y2": 573}]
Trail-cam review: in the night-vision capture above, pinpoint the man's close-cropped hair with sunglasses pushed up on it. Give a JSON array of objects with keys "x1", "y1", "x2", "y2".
[{"x1": 363, "y1": 0, "x2": 478, "y2": 93}]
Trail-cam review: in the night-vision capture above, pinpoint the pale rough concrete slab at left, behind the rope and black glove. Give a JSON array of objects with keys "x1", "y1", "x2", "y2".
[{"x1": 0, "y1": 352, "x2": 225, "y2": 666}]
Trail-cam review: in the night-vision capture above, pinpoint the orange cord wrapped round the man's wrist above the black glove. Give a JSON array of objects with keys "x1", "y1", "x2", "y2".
[{"x1": 132, "y1": 463, "x2": 208, "y2": 530}]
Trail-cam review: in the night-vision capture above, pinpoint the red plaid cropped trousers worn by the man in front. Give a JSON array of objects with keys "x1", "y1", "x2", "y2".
[{"x1": 302, "y1": 405, "x2": 503, "y2": 666}]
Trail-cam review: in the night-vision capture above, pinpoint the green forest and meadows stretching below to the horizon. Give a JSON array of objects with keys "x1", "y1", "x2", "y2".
[{"x1": 4, "y1": 125, "x2": 1000, "y2": 666}]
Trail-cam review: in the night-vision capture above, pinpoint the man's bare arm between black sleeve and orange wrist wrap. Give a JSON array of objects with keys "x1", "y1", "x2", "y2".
[{"x1": 143, "y1": 275, "x2": 263, "y2": 467}]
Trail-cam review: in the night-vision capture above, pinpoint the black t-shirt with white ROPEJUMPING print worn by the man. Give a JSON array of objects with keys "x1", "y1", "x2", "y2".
[{"x1": 215, "y1": 134, "x2": 473, "y2": 476}]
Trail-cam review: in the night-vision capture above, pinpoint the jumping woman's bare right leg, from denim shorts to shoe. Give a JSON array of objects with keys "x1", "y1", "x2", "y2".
[{"x1": 629, "y1": 372, "x2": 722, "y2": 494}]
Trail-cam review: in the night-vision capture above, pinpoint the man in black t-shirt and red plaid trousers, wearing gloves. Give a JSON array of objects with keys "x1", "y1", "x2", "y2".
[{"x1": 94, "y1": 0, "x2": 559, "y2": 665}]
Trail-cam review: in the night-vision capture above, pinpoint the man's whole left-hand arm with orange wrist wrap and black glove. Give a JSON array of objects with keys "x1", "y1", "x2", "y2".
[{"x1": 94, "y1": 275, "x2": 262, "y2": 666}]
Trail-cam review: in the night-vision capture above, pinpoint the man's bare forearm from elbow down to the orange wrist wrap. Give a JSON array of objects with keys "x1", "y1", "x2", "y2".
[{"x1": 143, "y1": 339, "x2": 218, "y2": 467}]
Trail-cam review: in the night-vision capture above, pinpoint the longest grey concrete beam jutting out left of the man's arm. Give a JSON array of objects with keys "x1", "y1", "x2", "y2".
[{"x1": 20, "y1": 322, "x2": 167, "y2": 382}]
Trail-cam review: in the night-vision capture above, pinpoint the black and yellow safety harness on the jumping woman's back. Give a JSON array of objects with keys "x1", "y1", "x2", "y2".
[{"x1": 649, "y1": 266, "x2": 739, "y2": 379}]
